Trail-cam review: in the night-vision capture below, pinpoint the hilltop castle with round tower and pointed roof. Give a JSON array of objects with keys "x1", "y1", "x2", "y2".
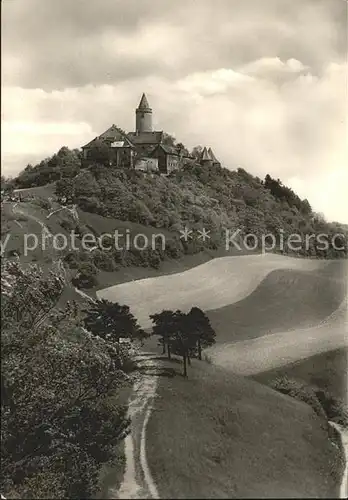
[{"x1": 82, "y1": 94, "x2": 220, "y2": 175}]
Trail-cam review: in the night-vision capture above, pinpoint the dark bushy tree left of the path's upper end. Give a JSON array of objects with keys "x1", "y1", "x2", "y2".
[{"x1": 84, "y1": 299, "x2": 147, "y2": 343}]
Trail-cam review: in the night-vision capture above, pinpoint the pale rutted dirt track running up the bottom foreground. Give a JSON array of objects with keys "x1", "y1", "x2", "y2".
[{"x1": 108, "y1": 353, "x2": 159, "y2": 499}]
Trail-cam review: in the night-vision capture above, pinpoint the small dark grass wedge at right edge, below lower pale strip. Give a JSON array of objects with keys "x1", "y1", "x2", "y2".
[{"x1": 253, "y1": 349, "x2": 348, "y2": 403}]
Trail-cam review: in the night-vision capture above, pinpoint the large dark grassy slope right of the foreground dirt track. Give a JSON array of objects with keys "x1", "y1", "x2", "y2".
[{"x1": 147, "y1": 361, "x2": 337, "y2": 498}]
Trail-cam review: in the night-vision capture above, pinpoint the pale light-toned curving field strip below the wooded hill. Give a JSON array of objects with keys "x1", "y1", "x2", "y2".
[{"x1": 98, "y1": 254, "x2": 327, "y2": 328}]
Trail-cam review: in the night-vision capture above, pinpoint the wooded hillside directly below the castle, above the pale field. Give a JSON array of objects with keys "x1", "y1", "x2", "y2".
[{"x1": 2, "y1": 147, "x2": 348, "y2": 300}]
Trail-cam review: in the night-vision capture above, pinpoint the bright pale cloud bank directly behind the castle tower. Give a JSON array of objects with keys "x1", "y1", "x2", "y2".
[{"x1": 2, "y1": 55, "x2": 348, "y2": 222}]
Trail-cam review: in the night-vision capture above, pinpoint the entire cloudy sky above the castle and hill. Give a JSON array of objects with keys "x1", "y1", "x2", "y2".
[{"x1": 1, "y1": 0, "x2": 348, "y2": 223}]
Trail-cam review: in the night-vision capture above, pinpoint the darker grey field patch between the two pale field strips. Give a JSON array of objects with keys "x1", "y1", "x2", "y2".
[{"x1": 208, "y1": 261, "x2": 347, "y2": 342}]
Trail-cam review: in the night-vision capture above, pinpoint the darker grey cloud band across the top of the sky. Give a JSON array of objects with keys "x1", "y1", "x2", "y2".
[{"x1": 2, "y1": 0, "x2": 346, "y2": 90}]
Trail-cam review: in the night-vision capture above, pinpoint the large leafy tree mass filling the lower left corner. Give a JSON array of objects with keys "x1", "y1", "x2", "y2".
[{"x1": 0, "y1": 262, "x2": 129, "y2": 498}]
